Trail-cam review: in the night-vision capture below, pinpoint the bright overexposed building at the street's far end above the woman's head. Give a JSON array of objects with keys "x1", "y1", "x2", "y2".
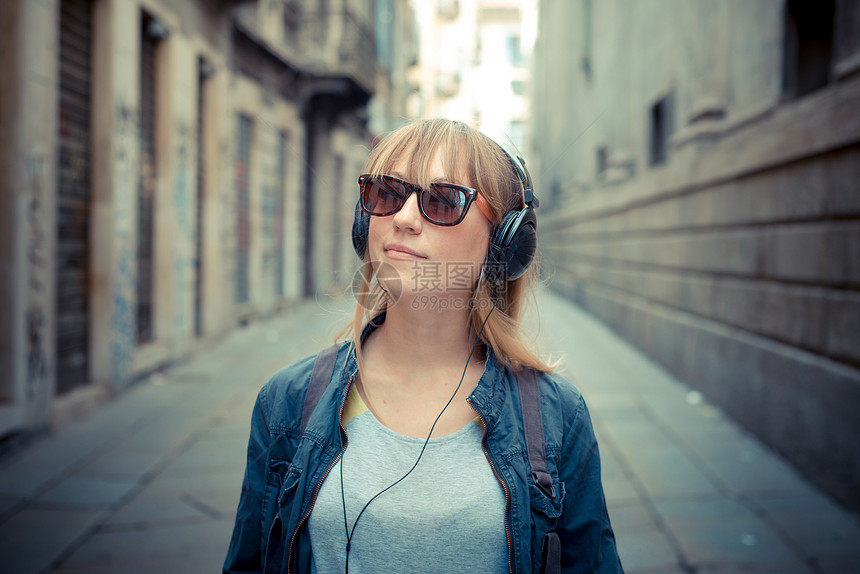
[{"x1": 409, "y1": 0, "x2": 537, "y2": 153}]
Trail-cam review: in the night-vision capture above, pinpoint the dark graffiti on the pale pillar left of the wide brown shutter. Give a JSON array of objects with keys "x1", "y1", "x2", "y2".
[{"x1": 25, "y1": 156, "x2": 50, "y2": 409}]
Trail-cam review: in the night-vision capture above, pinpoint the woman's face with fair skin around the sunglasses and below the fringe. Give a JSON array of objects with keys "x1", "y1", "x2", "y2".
[{"x1": 368, "y1": 149, "x2": 490, "y2": 310}]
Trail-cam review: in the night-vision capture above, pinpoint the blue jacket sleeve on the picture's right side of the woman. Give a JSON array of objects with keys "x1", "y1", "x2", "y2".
[{"x1": 556, "y1": 395, "x2": 623, "y2": 574}]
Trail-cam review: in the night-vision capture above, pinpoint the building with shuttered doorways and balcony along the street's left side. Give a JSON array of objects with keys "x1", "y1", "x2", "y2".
[{"x1": 0, "y1": 0, "x2": 414, "y2": 436}]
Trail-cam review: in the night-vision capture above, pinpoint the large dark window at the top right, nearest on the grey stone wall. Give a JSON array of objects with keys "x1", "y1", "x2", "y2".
[{"x1": 782, "y1": 0, "x2": 834, "y2": 98}]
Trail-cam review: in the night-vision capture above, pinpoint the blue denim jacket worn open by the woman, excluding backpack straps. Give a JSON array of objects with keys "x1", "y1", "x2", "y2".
[{"x1": 224, "y1": 343, "x2": 622, "y2": 574}]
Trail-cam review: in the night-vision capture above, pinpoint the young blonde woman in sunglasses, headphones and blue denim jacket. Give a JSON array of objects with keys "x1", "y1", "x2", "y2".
[{"x1": 224, "y1": 120, "x2": 621, "y2": 574}]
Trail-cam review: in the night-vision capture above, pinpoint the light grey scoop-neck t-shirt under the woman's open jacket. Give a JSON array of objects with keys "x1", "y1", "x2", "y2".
[{"x1": 308, "y1": 388, "x2": 508, "y2": 574}]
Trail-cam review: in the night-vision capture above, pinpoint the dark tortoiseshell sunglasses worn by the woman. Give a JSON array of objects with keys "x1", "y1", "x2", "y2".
[{"x1": 358, "y1": 174, "x2": 493, "y2": 226}]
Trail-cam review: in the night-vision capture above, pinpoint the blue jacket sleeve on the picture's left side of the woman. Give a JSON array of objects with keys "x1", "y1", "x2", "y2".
[{"x1": 223, "y1": 385, "x2": 270, "y2": 574}]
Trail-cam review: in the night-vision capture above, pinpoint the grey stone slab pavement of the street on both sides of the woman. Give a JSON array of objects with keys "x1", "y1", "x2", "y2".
[{"x1": 0, "y1": 292, "x2": 860, "y2": 574}]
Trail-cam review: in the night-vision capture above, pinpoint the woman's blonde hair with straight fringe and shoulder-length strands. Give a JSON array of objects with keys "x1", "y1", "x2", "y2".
[{"x1": 340, "y1": 119, "x2": 556, "y2": 371}]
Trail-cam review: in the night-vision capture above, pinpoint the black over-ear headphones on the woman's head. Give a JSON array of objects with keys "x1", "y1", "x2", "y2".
[{"x1": 352, "y1": 146, "x2": 539, "y2": 288}]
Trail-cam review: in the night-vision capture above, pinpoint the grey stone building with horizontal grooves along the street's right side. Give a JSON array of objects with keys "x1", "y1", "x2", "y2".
[{"x1": 532, "y1": 0, "x2": 860, "y2": 510}]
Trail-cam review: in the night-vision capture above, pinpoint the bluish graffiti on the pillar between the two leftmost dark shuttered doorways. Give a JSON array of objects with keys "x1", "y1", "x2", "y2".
[{"x1": 111, "y1": 104, "x2": 138, "y2": 383}]
